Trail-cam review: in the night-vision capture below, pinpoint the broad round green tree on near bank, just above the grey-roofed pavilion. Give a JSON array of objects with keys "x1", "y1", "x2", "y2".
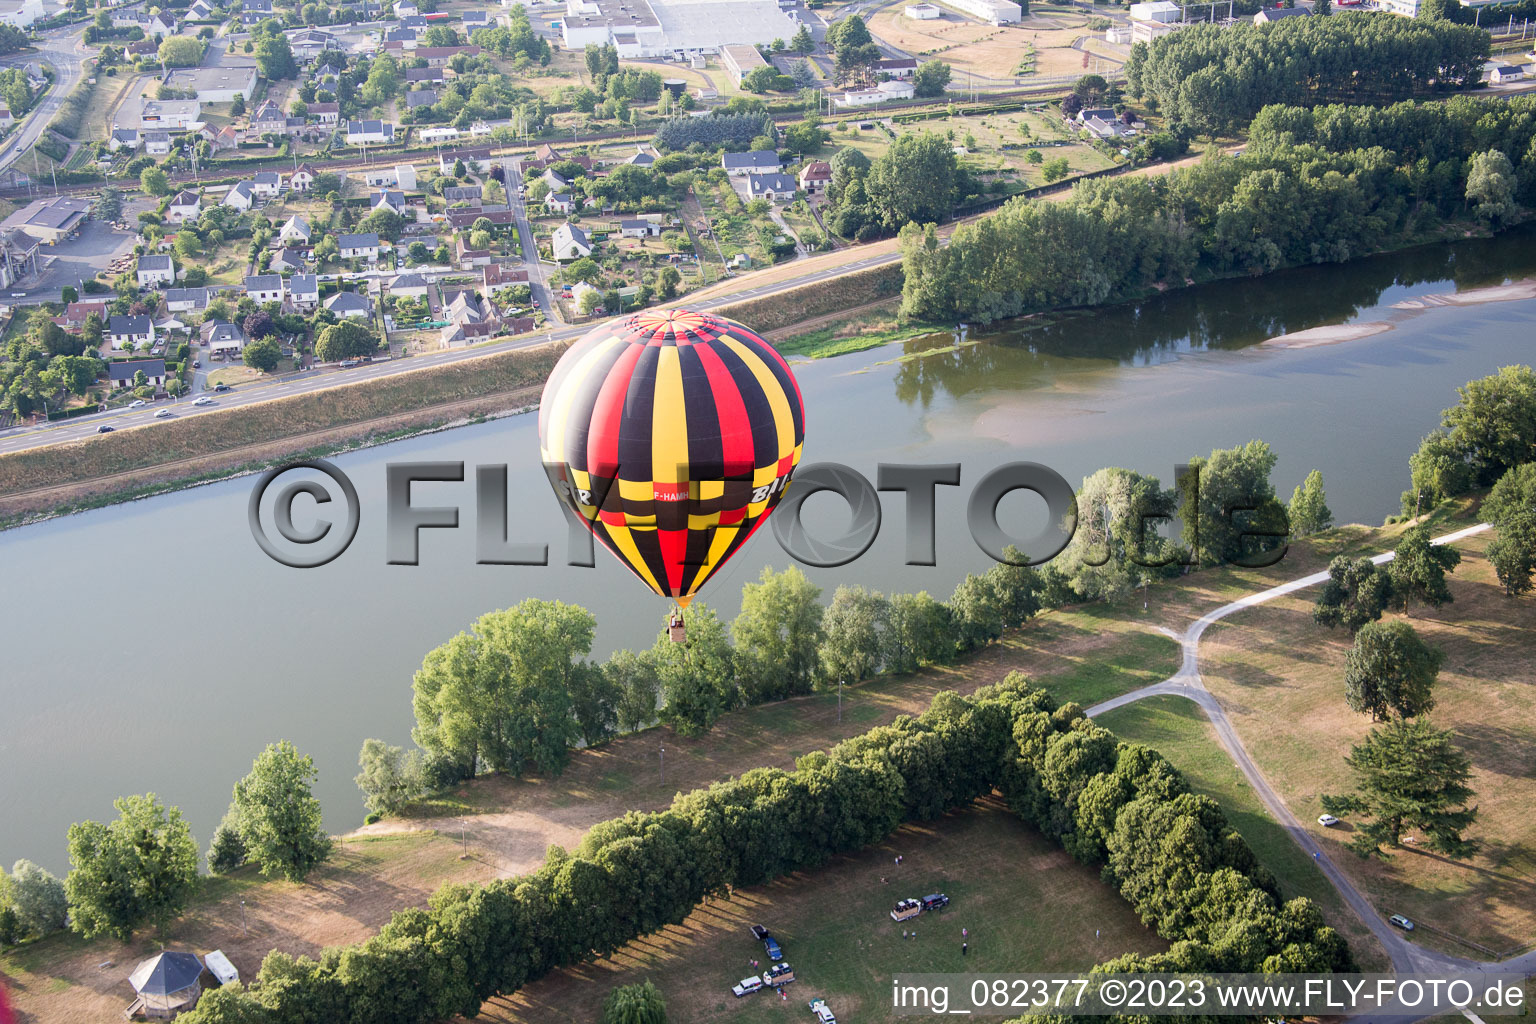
[{"x1": 65, "y1": 794, "x2": 198, "y2": 943}]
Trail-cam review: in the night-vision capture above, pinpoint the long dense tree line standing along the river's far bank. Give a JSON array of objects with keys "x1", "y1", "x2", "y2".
[{"x1": 902, "y1": 97, "x2": 1536, "y2": 322}]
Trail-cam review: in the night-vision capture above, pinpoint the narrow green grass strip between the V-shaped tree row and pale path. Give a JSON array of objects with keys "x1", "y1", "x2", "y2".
[{"x1": 1095, "y1": 695, "x2": 1392, "y2": 970}]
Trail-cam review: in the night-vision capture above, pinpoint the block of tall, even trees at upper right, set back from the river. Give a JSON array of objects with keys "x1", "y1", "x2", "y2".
[{"x1": 1126, "y1": 12, "x2": 1490, "y2": 134}]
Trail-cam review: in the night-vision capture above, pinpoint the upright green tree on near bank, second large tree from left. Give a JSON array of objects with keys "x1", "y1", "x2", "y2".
[{"x1": 232, "y1": 740, "x2": 330, "y2": 881}]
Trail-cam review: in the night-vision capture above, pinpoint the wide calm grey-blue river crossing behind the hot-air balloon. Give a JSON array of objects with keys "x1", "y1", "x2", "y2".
[{"x1": 0, "y1": 230, "x2": 1536, "y2": 872}]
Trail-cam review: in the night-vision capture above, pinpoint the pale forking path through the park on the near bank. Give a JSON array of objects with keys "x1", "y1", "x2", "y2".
[{"x1": 1087, "y1": 524, "x2": 1536, "y2": 1024}]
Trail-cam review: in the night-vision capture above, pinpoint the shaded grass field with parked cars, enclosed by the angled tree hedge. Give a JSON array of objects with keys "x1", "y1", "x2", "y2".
[{"x1": 478, "y1": 800, "x2": 1167, "y2": 1024}]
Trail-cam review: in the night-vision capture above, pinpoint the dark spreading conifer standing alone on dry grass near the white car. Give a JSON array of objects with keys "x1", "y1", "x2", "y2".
[{"x1": 1322, "y1": 718, "x2": 1478, "y2": 860}]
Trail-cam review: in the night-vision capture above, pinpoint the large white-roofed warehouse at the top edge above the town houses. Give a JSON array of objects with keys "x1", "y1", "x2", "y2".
[{"x1": 561, "y1": 0, "x2": 804, "y2": 60}]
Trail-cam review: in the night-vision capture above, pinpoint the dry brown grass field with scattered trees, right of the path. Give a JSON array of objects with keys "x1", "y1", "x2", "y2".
[{"x1": 1203, "y1": 521, "x2": 1536, "y2": 958}]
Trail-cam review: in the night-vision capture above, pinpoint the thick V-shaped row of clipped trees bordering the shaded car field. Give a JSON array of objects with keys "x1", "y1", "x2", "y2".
[{"x1": 183, "y1": 674, "x2": 1353, "y2": 1024}]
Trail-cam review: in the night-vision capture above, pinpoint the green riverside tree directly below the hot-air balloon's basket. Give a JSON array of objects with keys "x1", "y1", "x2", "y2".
[{"x1": 651, "y1": 600, "x2": 737, "y2": 735}]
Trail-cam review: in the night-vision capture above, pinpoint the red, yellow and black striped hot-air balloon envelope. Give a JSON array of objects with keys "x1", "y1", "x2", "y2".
[{"x1": 539, "y1": 309, "x2": 805, "y2": 606}]
